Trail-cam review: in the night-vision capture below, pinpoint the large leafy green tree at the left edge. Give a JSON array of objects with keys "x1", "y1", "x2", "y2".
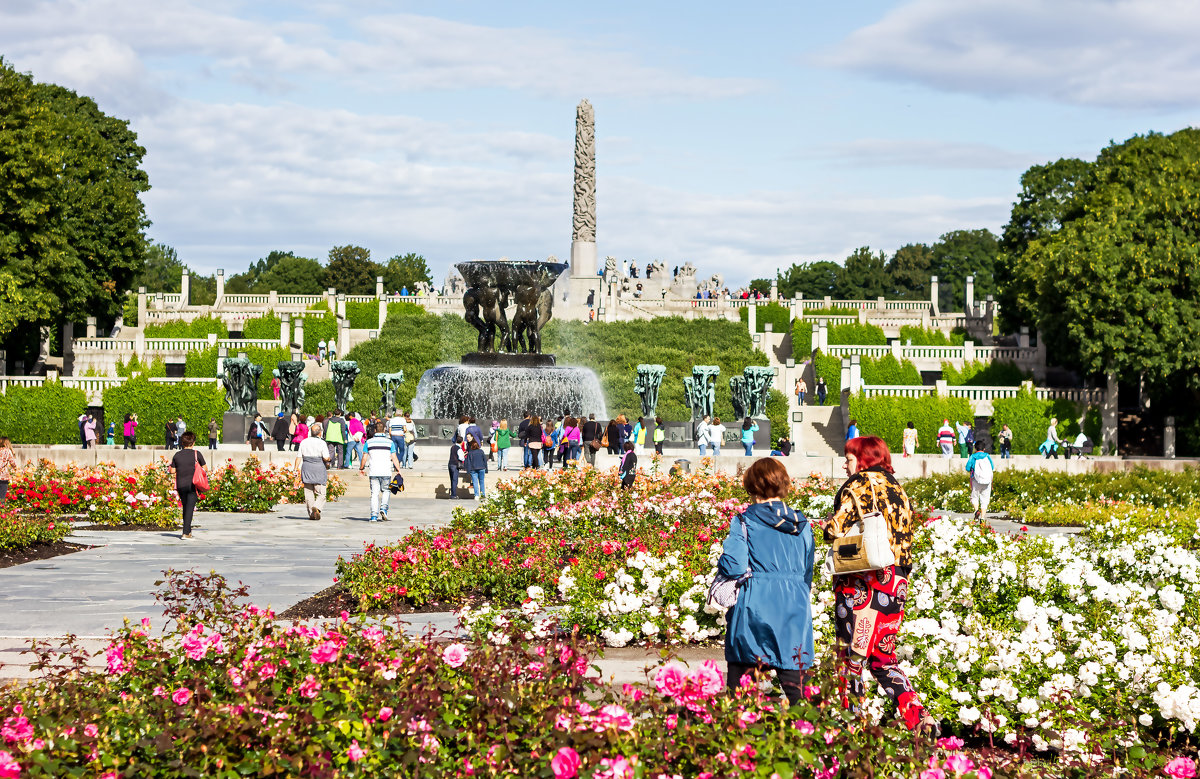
[{"x1": 0, "y1": 59, "x2": 150, "y2": 345}]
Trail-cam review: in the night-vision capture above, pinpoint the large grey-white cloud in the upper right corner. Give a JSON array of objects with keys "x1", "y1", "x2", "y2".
[{"x1": 820, "y1": 0, "x2": 1200, "y2": 109}]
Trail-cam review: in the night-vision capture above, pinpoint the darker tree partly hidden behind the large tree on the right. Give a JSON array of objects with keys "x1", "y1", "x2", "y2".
[{"x1": 994, "y1": 157, "x2": 1091, "y2": 332}]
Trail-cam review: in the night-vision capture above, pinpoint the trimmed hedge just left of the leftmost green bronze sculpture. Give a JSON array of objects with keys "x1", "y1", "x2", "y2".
[{"x1": 104, "y1": 376, "x2": 229, "y2": 445}]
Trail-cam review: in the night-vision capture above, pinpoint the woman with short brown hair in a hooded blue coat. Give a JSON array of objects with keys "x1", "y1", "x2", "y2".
[{"x1": 716, "y1": 459, "x2": 815, "y2": 703}]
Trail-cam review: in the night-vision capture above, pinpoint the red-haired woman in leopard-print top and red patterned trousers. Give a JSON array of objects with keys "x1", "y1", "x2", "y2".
[{"x1": 824, "y1": 436, "x2": 936, "y2": 730}]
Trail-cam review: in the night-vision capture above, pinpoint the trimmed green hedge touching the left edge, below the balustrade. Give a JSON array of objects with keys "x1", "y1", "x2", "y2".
[{"x1": 0, "y1": 382, "x2": 88, "y2": 444}]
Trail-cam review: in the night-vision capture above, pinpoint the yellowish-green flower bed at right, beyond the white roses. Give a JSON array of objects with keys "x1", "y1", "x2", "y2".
[{"x1": 905, "y1": 465, "x2": 1200, "y2": 511}]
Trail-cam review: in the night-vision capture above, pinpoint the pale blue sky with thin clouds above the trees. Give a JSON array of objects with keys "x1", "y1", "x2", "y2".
[{"x1": 0, "y1": 0, "x2": 1200, "y2": 286}]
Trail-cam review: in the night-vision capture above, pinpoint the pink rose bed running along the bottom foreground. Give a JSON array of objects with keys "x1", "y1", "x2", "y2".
[{"x1": 0, "y1": 564, "x2": 1180, "y2": 779}]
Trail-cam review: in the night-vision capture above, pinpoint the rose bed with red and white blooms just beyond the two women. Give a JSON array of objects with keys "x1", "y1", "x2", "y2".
[{"x1": 338, "y1": 460, "x2": 1200, "y2": 748}]
